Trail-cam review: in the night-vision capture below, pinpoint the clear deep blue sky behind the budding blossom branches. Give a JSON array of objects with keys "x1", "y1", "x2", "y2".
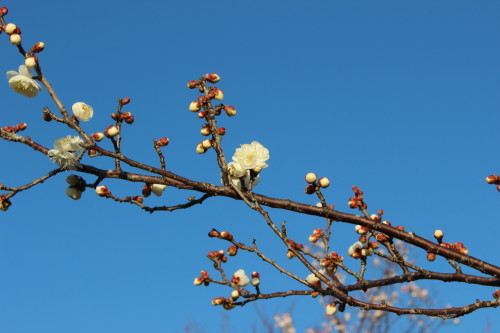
[{"x1": 0, "y1": 0, "x2": 500, "y2": 333}]
